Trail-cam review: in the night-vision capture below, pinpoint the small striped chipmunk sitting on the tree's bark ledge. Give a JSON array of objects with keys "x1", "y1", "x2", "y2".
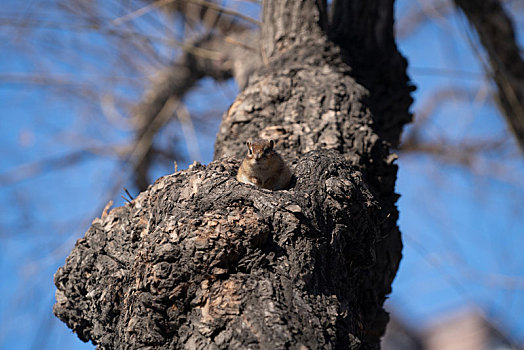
[{"x1": 237, "y1": 140, "x2": 291, "y2": 190}]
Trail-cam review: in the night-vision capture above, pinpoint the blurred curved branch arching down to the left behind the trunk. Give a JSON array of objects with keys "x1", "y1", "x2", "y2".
[{"x1": 131, "y1": 30, "x2": 260, "y2": 191}]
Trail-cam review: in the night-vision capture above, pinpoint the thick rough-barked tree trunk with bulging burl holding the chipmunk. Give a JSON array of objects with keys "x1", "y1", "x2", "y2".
[{"x1": 54, "y1": 0, "x2": 412, "y2": 349}]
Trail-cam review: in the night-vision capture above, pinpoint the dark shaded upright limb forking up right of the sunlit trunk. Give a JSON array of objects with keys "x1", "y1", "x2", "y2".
[{"x1": 328, "y1": 0, "x2": 415, "y2": 147}]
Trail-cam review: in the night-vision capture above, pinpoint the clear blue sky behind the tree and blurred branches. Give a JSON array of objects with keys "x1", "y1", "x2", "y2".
[{"x1": 0, "y1": 0, "x2": 524, "y2": 349}]
